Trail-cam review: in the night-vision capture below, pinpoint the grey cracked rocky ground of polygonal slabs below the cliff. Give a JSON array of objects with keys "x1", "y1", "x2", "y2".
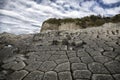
[{"x1": 0, "y1": 27, "x2": 120, "y2": 80}]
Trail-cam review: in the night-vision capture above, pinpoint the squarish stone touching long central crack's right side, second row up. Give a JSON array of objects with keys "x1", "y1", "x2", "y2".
[{"x1": 72, "y1": 63, "x2": 87, "y2": 70}]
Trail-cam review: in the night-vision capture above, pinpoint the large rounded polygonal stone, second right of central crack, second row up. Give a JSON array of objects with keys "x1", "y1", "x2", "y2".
[{"x1": 88, "y1": 62, "x2": 109, "y2": 74}]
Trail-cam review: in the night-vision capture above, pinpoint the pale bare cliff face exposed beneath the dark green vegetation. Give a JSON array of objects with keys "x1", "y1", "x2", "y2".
[{"x1": 40, "y1": 22, "x2": 120, "y2": 32}]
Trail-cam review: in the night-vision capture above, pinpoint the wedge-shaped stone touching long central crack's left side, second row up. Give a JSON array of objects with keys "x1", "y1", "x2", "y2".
[{"x1": 55, "y1": 62, "x2": 70, "y2": 72}]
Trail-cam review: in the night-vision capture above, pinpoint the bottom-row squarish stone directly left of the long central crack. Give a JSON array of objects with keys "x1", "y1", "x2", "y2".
[{"x1": 58, "y1": 72, "x2": 72, "y2": 80}]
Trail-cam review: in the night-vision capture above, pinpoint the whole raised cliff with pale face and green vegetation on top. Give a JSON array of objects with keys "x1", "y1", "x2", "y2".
[{"x1": 40, "y1": 14, "x2": 120, "y2": 32}]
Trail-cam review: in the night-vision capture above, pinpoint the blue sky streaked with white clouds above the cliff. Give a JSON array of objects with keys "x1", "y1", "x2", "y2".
[{"x1": 0, "y1": 0, "x2": 120, "y2": 34}]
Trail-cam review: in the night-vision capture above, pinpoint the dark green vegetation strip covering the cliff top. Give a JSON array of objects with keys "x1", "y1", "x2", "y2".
[{"x1": 43, "y1": 14, "x2": 120, "y2": 28}]
